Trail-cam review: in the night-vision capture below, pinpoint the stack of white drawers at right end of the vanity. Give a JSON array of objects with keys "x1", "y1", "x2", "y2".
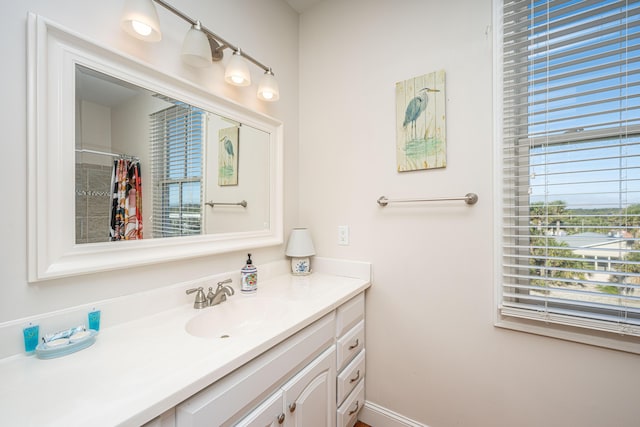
[{"x1": 336, "y1": 293, "x2": 365, "y2": 427}]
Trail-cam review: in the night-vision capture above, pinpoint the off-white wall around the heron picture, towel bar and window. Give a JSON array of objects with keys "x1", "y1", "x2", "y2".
[{"x1": 299, "y1": 0, "x2": 640, "y2": 427}]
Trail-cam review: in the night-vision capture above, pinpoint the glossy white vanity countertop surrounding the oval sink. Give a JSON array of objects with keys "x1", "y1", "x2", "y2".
[{"x1": 0, "y1": 273, "x2": 369, "y2": 427}]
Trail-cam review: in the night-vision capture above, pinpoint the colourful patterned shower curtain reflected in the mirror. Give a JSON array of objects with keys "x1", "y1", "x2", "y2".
[{"x1": 110, "y1": 159, "x2": 142, "y2": 240}]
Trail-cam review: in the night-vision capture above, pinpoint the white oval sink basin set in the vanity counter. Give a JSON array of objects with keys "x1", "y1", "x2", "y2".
[{"x1": 185, "y1": 294, "x2": 288, "y2": 338}]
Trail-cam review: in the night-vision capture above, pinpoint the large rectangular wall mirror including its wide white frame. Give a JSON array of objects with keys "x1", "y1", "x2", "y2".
[{"x1": 28, "y1": 14, "x2": 283, "y2": 282}]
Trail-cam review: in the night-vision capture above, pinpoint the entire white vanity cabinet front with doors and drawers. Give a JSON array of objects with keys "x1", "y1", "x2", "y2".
[{"x1": 175, "y1": 292, "x2": 365, "y2": 427}]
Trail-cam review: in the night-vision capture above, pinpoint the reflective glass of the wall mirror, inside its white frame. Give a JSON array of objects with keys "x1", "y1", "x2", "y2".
[{"x1": 75, "y1": 65, "x2": 270, "y2": 244}]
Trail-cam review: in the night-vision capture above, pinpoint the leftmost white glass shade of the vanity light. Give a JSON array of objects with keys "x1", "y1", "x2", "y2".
[{"x1": 120, "y1": 0, "x2": 162, "y2": 42}]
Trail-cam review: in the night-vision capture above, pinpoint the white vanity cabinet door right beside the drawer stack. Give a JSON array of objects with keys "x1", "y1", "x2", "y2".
[{"x1": 282, "y1": 346, "x2": 336, "y2": 427}]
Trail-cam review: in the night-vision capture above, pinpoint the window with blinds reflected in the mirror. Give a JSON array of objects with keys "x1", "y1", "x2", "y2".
[{"x1": 150, "y1": 105, "x2": 204, "y2": 237}]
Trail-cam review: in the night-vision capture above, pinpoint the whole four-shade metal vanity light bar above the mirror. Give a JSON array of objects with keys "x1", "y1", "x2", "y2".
[{"x1": 121, "y1": 0, "x2": 280, "y2": 102}]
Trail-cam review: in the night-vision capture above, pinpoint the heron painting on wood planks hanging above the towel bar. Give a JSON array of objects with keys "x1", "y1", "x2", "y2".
[{"x1": 396, "y1": 71, "x2": 447, "y2": 172}]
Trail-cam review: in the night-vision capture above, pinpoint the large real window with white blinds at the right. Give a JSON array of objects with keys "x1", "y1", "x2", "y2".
[{"x1": 497, "y1": 0, "x2": 640, "y2": 337}]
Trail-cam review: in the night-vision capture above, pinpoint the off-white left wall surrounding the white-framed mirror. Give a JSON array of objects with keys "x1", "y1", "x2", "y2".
[{"x1": 0, "y1": 0, "x2": 298, "y2": 322}]
